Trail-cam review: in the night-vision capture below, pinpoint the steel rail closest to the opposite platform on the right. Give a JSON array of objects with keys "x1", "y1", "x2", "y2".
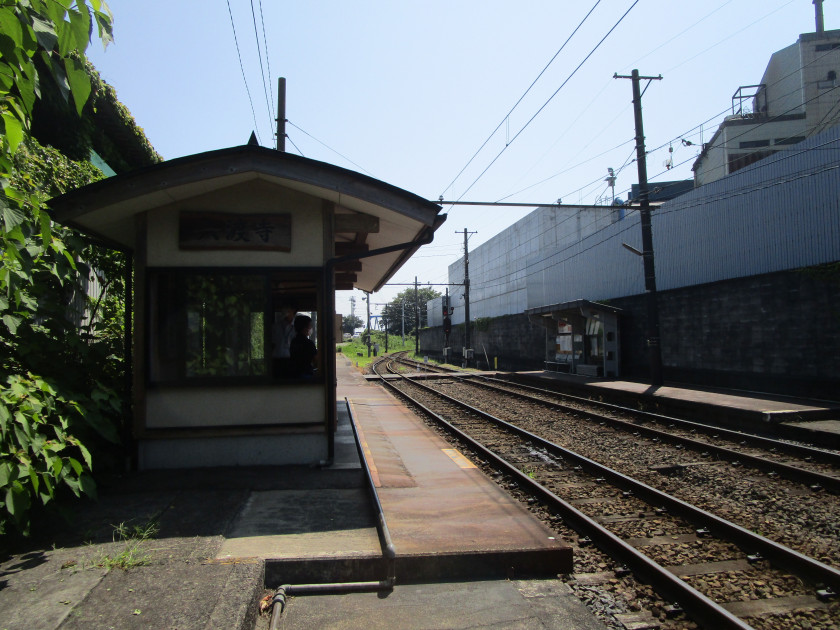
[{"x1": 476, "y1": 376, "x2": 840, "y2": 467}]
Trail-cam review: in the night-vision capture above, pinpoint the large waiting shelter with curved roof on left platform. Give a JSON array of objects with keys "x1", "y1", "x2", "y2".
[{"x1": 50, "y1": 145, "x2": 446, "y2": 469}]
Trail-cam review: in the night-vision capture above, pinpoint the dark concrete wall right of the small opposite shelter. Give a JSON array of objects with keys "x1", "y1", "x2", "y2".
[{"x1": 610, "y1": 264, "x2": 840, "y2": 399}]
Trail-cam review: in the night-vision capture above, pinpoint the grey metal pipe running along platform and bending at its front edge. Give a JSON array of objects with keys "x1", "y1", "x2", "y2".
[{"x1": 269, "y1": 397, "x2": 397, "y2": 630}]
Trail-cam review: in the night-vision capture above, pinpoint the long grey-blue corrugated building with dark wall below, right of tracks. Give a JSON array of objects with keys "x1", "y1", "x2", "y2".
[{"x1": 421, "y1": 127, "x2": 840, "y2": 396}]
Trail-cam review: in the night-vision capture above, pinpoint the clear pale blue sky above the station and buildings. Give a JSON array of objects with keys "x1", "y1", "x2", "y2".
[{"x1": 89, "y1": 0, "x2": 840, "y2": 324}]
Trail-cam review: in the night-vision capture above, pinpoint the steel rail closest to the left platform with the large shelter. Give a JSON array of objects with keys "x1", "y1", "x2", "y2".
[{"x1": 374, "y1": 368, "x2": 752, "y2": 630}]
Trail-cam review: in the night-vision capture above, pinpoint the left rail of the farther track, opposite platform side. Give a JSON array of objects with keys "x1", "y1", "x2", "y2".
[{"x1": 461, "y1": 379, "x2": 840, "y2": 493}]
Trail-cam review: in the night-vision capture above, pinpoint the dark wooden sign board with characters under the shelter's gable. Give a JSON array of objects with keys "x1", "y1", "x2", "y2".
[{"x1": 178, "y1": 212, "x2": 292, "y2": 252}]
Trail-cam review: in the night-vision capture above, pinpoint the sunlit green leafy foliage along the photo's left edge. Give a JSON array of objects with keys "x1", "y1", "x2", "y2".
[{"x1": 0, "y1": 0, "x2": 122, "y2": 533}]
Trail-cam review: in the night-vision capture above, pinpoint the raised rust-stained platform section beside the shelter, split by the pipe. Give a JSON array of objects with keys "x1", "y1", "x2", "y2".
[{"x1": 253, "y1": 357, "x2": 572, "y2": 587}]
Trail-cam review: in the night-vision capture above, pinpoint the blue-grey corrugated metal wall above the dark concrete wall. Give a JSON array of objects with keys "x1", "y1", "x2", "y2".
[{"x1": 527, "y1": 127, "x2": 840, "y2": 308}]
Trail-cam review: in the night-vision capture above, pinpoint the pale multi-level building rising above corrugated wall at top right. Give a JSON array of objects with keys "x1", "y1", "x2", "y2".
[{"x1": 692, "y1": 26, "x2": 840, "y2": 186}]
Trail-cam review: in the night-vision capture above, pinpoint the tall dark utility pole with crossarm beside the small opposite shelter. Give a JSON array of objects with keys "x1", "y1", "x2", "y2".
[{"x1": 613, "y1": 70, "x2": 663, "y2": 386}]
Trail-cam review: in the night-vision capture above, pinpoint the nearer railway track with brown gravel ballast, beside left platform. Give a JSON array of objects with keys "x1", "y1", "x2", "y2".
[{"x1": 374, "y1": 360, "x2": 840, "y2": 628}]
